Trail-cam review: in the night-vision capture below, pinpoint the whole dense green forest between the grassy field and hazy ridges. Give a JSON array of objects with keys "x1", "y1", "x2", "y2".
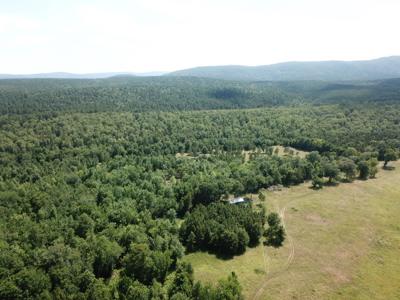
[{"x1": 0, "y1": 78, "x2": 400, "y2": 299}]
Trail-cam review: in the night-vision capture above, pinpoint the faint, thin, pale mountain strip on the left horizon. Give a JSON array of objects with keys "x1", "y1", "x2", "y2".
[{"x1": 0, "y1": 72, "x2": 165, "y2": 79}]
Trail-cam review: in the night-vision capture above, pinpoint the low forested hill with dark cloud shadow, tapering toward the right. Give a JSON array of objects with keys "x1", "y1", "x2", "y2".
[{"x1": 0, "y1": 77, "x2": 300, "y2": 113}]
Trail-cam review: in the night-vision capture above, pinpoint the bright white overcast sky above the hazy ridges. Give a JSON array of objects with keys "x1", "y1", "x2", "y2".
[{"x1": 0, "y1": 0, "x2": 400, "y2": 74}]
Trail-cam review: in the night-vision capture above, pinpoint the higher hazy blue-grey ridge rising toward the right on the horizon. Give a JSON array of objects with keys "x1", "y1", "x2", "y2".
[{"x1": 167, "y1": 56, "x2": 400, "y2": 81}]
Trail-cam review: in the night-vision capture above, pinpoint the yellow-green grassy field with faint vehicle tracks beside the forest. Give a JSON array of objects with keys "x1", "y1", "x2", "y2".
[{"x1": 185, "y1": 162, "x2": 400, "y2": 299}]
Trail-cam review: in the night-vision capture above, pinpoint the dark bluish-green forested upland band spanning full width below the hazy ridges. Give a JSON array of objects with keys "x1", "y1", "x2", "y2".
[{"x1": 0, "y1": 77, "x2": 400, "y2": 114}]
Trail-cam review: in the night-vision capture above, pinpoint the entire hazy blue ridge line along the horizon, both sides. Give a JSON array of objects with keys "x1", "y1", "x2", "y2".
[{"x1": 0, "y1": 56, "x2": 400, "y2": 81}]
